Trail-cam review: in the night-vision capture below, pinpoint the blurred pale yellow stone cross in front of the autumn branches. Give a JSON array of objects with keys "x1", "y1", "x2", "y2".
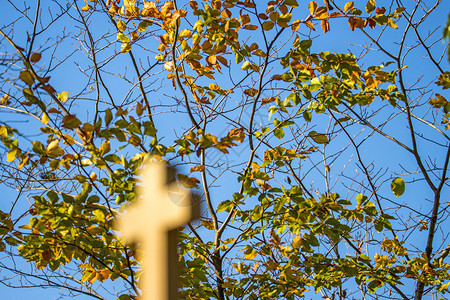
[{"x1": 119, "y1": 162, "x2": 199, "y2": 300}]
